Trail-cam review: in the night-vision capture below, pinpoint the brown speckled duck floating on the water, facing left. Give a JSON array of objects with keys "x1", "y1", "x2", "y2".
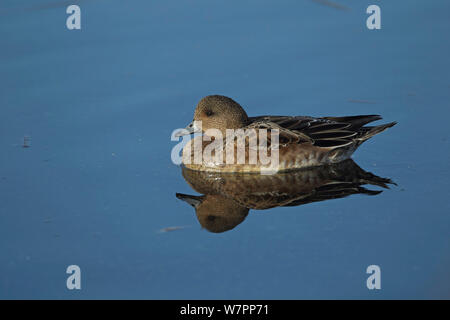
[{"x1": 175, "y1": 95, "x2": 397, "y2": 174}]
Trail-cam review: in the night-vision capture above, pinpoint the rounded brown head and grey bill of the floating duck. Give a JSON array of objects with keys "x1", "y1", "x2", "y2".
[{"x1": 177, "y1": 95, "x2": 248, "y2": 136}]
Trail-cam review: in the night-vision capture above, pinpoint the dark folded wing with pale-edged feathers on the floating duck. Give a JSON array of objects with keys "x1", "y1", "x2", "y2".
[{"x1": 248, "y1": 115, "x2": 381, "y2": 148}]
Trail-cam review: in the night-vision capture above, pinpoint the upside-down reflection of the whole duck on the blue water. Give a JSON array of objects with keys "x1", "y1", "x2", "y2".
[{"x1": 176, "y1": 159, "x2": 393, "y2": 232}]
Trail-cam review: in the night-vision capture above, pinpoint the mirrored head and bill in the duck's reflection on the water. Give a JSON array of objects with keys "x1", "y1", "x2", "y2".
[{"x1": 176, "y1": 193, "x2": 249, "y2": 233}]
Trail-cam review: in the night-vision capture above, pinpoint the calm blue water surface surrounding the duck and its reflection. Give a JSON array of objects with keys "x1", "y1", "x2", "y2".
[{"x1": 0, "y1": 0, "x2": 450, "y2": 299}]
